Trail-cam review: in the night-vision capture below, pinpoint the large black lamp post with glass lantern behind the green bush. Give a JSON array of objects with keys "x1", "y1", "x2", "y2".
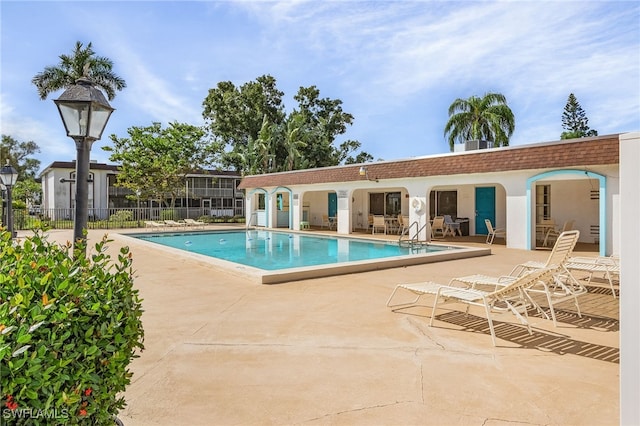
[{"x1": 53, "y1": 77, "x2": 113, "y2": 253}]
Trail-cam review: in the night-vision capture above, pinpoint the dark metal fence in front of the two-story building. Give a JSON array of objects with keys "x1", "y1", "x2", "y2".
[{"x1": 2, "y1": 207, "x2": 244, "y2": 230}]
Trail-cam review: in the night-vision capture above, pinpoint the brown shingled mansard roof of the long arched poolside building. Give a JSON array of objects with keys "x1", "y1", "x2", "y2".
[{"x1": 238, "y1": 134, "x2": 619, "y2": 189}]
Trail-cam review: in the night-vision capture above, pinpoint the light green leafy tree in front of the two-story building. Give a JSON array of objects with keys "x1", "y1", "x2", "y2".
[{"x1": 102, "y1": 123, "x2": 213, "y2": 207}]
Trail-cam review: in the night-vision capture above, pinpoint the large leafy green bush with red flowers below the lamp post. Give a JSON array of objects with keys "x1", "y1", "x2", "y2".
[{"x1": 0, "y1": 229, "x2": 144, "y2": 425}]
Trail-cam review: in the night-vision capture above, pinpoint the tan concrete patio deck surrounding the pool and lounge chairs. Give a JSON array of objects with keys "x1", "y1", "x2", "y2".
[{"x1": 26, "y1": 230, "x2": 620, "y2": 426}]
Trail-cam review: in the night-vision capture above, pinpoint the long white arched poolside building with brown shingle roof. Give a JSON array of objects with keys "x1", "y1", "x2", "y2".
[{"x1": 240, "y1": 135, "x2": 632, "y2": 255}]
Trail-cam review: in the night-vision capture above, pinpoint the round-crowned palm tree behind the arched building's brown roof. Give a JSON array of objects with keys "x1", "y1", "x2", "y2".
[{"x1": 444, "y1": 93, "x2": 515, "y2": 151}]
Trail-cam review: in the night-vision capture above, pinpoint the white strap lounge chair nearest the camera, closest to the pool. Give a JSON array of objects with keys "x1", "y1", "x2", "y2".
[{"x1": 429, "y1": 269, "x2": 553, "y2": 346}]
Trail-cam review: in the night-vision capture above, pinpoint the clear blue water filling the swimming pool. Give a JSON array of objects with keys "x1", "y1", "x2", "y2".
[{"x1": 136, "y1": 230, "x2": 451, "y2": 271}]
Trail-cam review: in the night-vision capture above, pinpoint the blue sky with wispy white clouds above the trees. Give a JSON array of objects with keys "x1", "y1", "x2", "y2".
[{"x1": 0, "y1": 0, "x2": 640, "y2": 172}]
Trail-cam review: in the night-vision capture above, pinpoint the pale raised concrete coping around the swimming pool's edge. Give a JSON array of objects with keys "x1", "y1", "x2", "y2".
[{"x1": 118, "y1": 228, "x2": 491, "y2": 284}]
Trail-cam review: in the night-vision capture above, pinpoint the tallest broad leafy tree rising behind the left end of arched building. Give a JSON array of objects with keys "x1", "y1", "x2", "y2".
[{"x1": 203, "y1": 75, "x2": 371, "y2": 174}]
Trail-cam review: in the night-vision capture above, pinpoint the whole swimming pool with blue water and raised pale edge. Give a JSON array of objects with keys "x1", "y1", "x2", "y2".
[{"x1": 130, "y1": 230, "x2": 490, "y2": 284}]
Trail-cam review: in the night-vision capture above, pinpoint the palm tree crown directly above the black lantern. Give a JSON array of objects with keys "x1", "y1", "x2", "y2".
[{"x1": 31, "y1": 41, "x2": 127, "y2": 100}]
